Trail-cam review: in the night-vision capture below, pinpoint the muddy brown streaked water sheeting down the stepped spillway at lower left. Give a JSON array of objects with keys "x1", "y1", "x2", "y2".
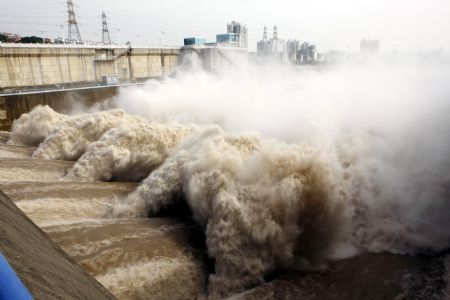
[{"x1": 0, "y1": 154, "x2": 207, "y2": 299}]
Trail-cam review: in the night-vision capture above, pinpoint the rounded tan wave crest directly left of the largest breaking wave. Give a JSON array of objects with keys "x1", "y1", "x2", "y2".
[{"x1": 64, "y1": 122, "x2": 193, "y2": 181}]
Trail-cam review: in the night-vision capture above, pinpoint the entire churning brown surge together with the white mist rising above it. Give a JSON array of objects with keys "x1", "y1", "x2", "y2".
[{"x1": 7, "y1": 58, "x2": 450, "y2": 298}]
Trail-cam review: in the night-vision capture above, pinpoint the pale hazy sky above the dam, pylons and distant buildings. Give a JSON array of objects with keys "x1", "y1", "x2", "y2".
[{"x1": 0, "y1": 0, "x2": 450, "y2": 52}]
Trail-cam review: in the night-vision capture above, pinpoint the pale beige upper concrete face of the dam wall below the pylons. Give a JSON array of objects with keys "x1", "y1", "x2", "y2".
[{"x1": 0, "y1": 44, "x2": 180, "y2": 91}]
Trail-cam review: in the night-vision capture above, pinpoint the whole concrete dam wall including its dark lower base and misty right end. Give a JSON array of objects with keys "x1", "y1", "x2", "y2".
[{"x1": 0, "y1": 43, "x2": 247, "y2": 129}]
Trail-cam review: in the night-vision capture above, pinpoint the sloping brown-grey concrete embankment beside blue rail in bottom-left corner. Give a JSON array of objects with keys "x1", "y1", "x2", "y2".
[{"x1": 0, "y1": 193, "x2": 114, "y2": 300}]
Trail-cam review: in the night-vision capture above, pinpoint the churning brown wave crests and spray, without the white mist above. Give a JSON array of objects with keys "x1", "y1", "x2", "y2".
[{"x1": 10, "y1": 81, "x2": 450, "y2": 298}]
